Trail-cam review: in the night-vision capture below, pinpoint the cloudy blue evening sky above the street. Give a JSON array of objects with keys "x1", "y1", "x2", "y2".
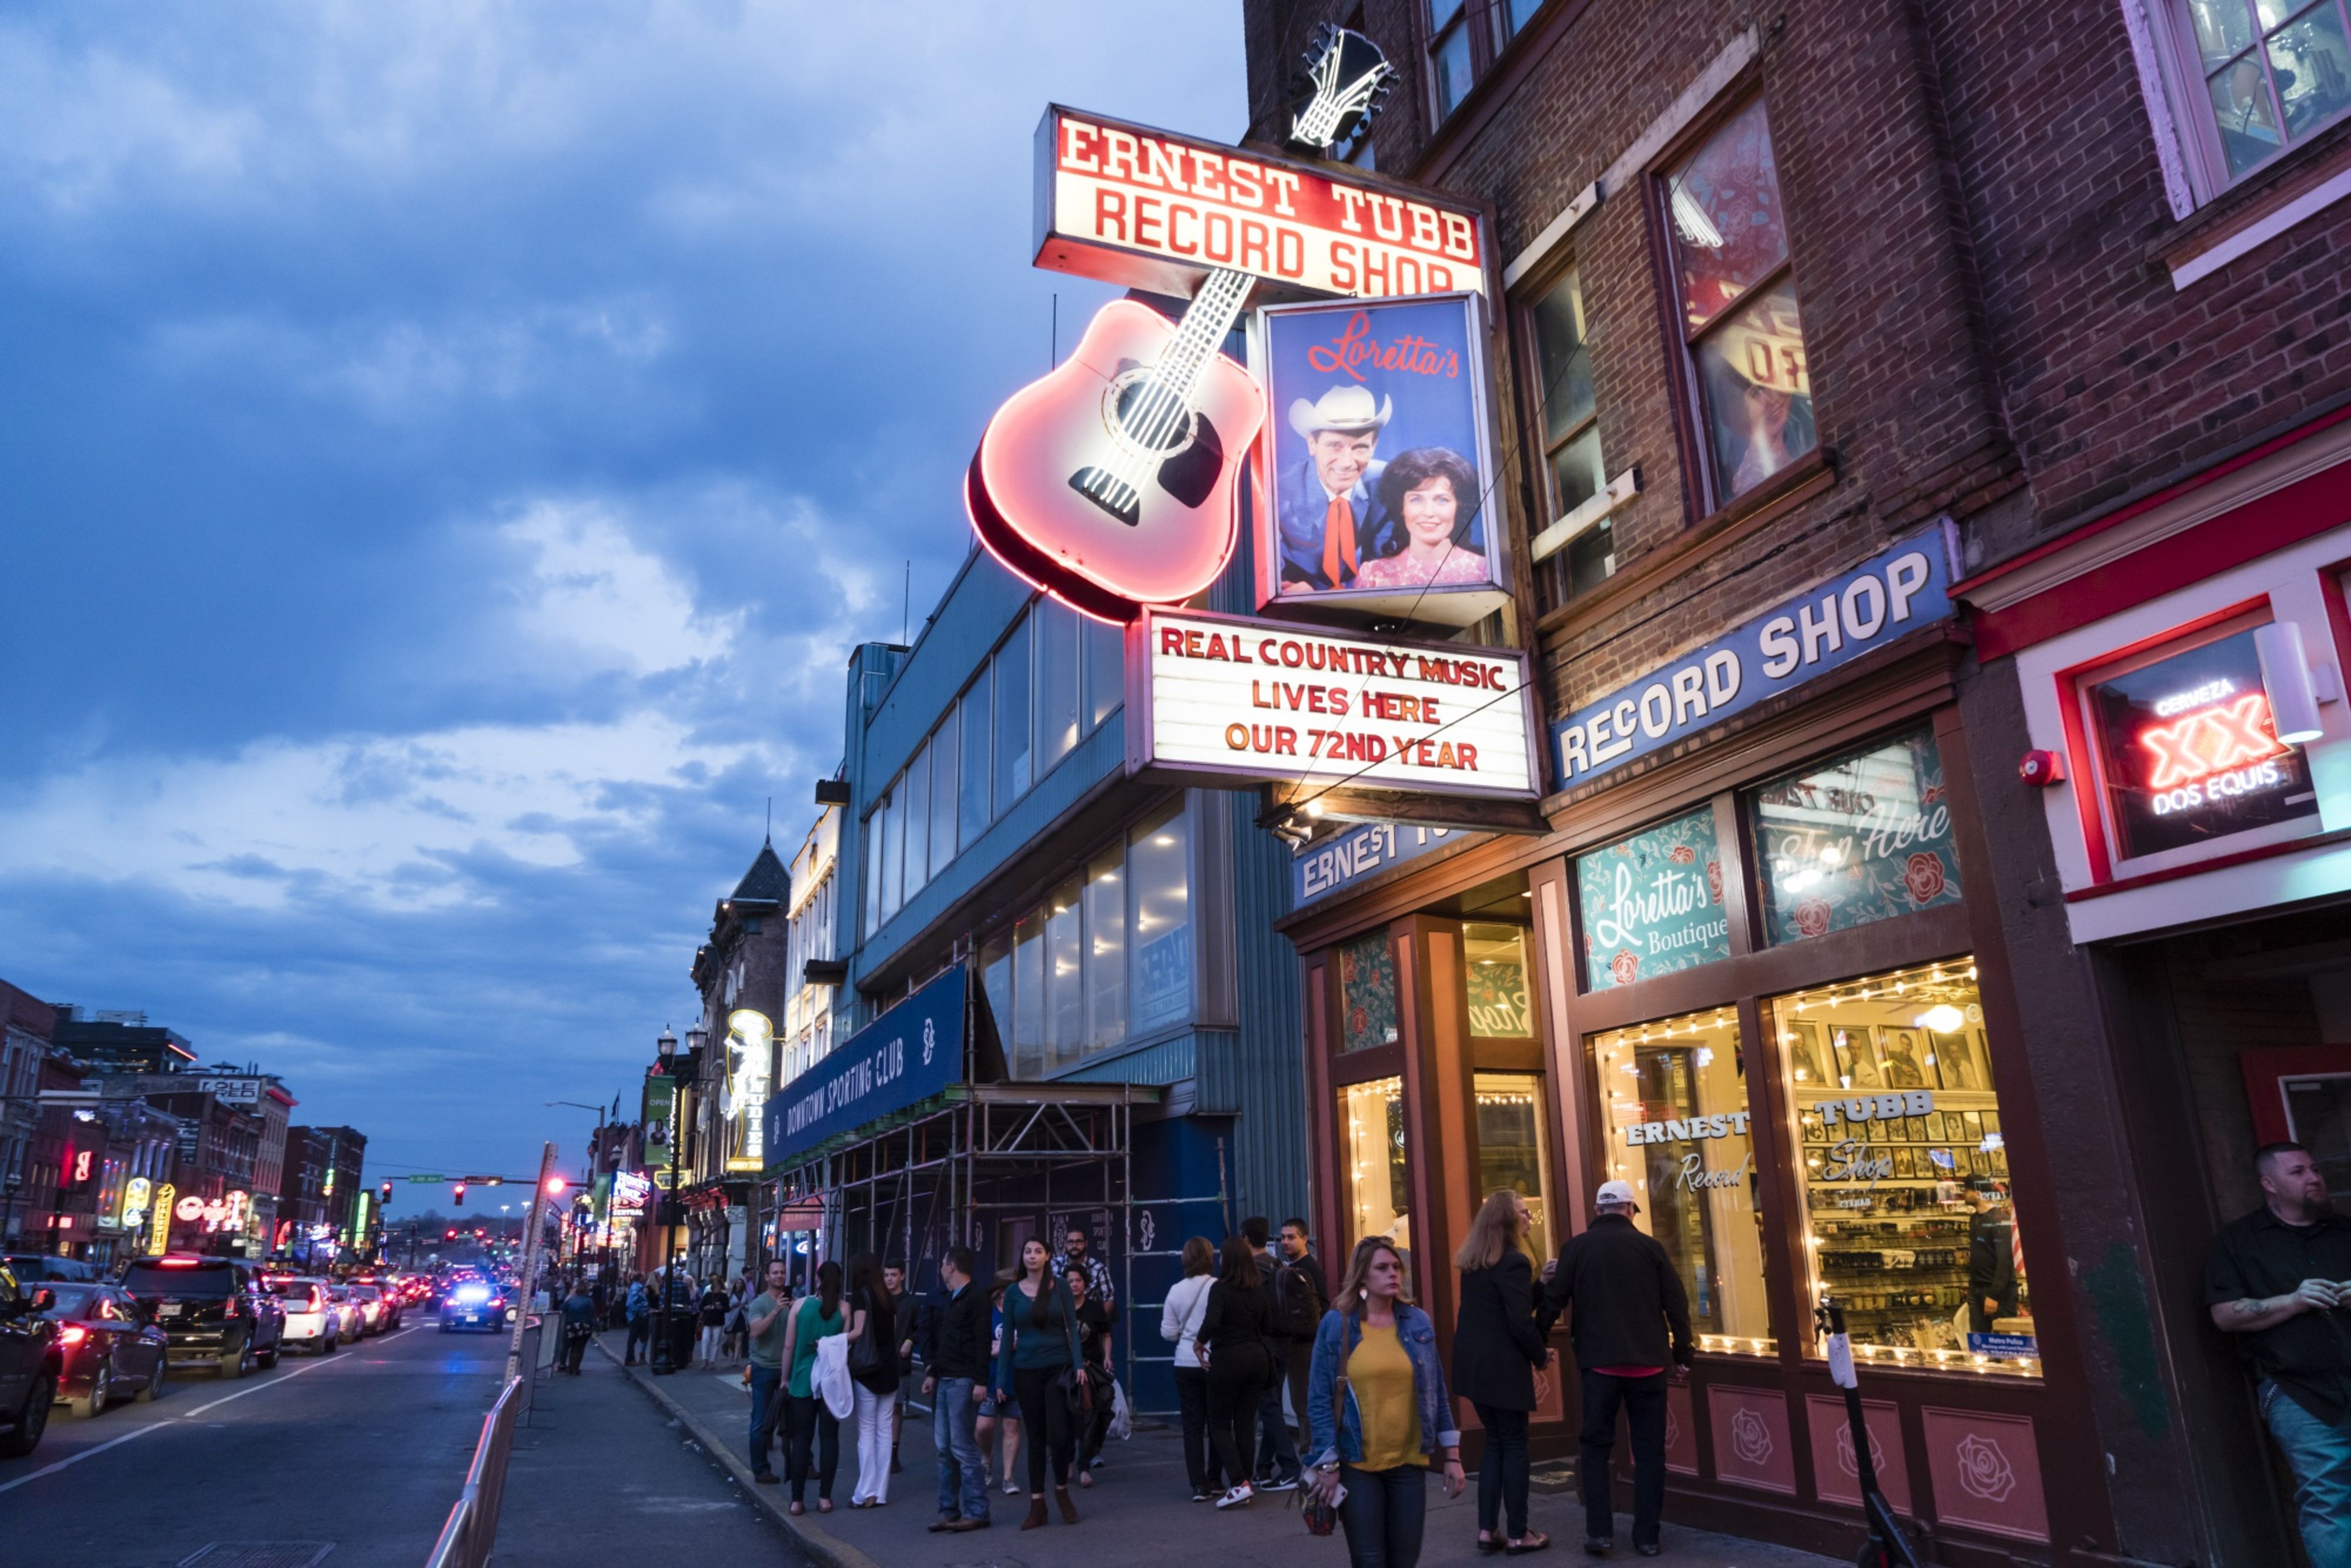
[{"x1": 0, "y1": 0, "x2": 1244, "y2": 1213}]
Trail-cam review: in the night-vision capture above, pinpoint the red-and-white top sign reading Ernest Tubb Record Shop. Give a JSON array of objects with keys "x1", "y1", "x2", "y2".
[{"x1": 1037, "y1": 103, "x2": 1486, "y2": 299}]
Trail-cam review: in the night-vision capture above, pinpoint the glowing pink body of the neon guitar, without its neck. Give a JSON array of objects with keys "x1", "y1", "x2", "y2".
[{"x1": 966, "y1": 301, "x2": 1265, "y2": 623}]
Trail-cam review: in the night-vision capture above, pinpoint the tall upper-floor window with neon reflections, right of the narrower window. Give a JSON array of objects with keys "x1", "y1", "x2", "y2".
[{"x1": 1665, "y1": 99, "x2": 1820, "y2": 510}]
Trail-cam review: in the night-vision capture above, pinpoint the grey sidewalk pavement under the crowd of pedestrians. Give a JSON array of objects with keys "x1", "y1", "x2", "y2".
[{"x1": 600, "y1": 1333, "x2": 1838, "y2": 1568}]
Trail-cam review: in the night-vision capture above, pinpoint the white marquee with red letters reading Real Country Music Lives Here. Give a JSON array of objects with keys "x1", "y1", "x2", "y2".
[{"x1": 1126, "y1": 609, "x2": 1542, "y2": 799}]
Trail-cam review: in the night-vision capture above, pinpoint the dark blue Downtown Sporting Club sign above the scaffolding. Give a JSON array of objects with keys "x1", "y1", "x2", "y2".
[{"x1": 764, "y1": 964, "x2": 966, "y2": 1171}]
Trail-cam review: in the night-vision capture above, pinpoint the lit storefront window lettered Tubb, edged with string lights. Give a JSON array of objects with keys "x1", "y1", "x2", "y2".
[{"x1": 1768, "y1": 957, "x2": 2041, "y2": 1375}]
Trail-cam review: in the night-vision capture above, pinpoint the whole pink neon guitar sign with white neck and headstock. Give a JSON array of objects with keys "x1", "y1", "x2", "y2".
[{"x1": 964, "y1": 28, "x2": 1389, "y2": 625}]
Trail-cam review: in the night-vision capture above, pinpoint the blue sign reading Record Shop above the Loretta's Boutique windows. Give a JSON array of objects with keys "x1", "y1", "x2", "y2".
[{"x1": 1552, "y1": 527, "x2": 1951, "y2": 788}]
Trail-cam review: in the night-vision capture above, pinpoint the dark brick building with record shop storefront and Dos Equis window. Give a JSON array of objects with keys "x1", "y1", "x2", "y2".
[{"x1": 1244, "y1": 0, "x2": 2351, "y2": 1563}]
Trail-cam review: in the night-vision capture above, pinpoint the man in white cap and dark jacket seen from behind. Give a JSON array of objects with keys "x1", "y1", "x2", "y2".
[{"x1": 1535, "y1": 1182, "x2": 1690, "y2": 1556}]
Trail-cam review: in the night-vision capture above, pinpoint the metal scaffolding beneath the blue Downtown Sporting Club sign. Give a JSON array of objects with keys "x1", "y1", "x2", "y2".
[{"x1": 773, "y1": 1081, "x2": 1232, "y2": 1415}]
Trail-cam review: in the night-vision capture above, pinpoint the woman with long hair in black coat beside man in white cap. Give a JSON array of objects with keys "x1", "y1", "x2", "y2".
[{"x1": 1453, "y1": 1187, "x2": 1552, "y2": 1556}]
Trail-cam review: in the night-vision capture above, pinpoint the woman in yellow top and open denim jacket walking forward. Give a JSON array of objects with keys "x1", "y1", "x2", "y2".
[{"x1": 1307, "y1": 1237, "x2": 1465, "y2": 1568}]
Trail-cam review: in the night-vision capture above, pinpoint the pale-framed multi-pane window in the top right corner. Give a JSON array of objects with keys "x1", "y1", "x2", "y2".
[{"x1": 2179, "y1": 0, "x2": 2351, "y2": 186}]
